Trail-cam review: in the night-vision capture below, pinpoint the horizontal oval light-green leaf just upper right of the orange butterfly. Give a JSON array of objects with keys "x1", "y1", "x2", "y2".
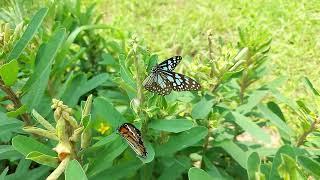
[{"x1": 148, "y1": 119, "x2": 193, "y2": 133}]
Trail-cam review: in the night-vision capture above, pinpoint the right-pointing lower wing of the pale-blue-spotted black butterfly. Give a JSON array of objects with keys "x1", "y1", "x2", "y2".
[{"x1": 161, "y1": 71, "x2": 201, "y2": 91}]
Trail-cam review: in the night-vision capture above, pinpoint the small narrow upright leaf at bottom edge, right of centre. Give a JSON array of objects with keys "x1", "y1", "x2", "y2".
[{"x1": 247, "y1": 152, "x2": 260, "y2": 180}]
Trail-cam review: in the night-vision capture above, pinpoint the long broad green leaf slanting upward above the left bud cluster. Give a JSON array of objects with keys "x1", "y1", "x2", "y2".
[{"x1": 22, "y1": 29, "x2": 66, "y2": 110}]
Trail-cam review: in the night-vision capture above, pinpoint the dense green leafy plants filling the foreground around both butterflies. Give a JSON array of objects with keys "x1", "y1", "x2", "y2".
[{"x1": 0, "y1": 0, "x2": 320, "y2": 180}]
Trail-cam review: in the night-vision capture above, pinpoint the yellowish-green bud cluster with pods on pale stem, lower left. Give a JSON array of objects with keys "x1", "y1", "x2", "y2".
[{"x1": 24, "y1": 95, "x2": 92, "y2": 179}]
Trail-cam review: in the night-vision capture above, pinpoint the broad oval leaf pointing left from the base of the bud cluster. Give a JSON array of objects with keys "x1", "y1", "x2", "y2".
[{"x1": 12, "y1": 135, "x2": 56, "y2": 156}]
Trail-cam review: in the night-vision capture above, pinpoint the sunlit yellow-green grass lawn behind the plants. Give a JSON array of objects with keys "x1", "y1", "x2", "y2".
[{"x1": 100, "y1": 0, "x2": 320, "y2": 98}]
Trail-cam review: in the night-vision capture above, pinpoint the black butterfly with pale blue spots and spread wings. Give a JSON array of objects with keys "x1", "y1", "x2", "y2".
[{"x1": 143, "y1": 56, "x2": 201, "y2": 96}]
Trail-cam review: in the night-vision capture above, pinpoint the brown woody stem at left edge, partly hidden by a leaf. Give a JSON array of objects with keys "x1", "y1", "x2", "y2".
[{"x1": 0, "y1": 79, "x2": 30, "y2": 125}]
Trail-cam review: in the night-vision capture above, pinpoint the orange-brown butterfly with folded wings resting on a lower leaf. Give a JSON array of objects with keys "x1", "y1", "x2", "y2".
[{"x1": 118, "y1": 123, "x2": 148, "y2": 158}]
